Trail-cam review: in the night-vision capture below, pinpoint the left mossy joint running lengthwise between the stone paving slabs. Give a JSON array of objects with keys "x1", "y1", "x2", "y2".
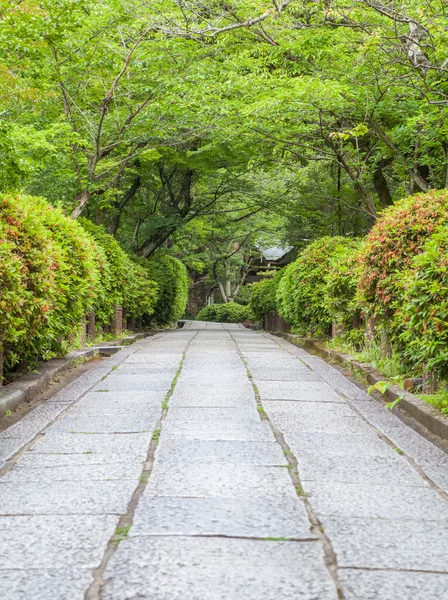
[{"x1": 84, "y1": 332, "x2": 199, "y2": 600}]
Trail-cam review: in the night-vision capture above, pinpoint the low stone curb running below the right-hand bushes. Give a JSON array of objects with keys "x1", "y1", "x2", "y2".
[{"x1": 269, "y1": 332, "x2": 448, "y2": 440}]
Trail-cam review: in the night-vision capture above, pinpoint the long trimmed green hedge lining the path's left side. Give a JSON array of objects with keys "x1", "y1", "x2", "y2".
[{"x1": 0, "y1": 195, "x2": 178, "y2": 384}]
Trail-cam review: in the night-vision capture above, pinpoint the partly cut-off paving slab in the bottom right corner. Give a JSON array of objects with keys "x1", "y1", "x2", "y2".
[{"x1": 339, "y1": 569, "x2": 448, "y2": 600}]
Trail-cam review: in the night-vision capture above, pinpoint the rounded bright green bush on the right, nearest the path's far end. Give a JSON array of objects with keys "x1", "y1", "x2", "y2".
[{"x1": 276, "y1": 237, "x2": 353, "y2": 334}]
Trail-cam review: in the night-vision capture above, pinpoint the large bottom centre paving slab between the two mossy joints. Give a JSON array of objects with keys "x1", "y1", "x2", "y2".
[{"x1": 103, "y1": 537, "x2": 337, "y2": 600}]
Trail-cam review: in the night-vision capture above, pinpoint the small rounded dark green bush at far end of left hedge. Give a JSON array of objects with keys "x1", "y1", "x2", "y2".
[{"x1": 144, "y1": 254, "x2": 189, "y2": 327}]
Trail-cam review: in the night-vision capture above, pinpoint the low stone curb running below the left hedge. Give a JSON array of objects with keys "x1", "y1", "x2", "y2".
[{"x1": 0, "y1": 329, "x2": 166, "y2": 418}]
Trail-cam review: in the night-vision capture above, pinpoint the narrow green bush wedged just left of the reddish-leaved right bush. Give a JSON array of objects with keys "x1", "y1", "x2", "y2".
[{"x1": 325, "y1": 239, "x2": 362, "y2": 329}]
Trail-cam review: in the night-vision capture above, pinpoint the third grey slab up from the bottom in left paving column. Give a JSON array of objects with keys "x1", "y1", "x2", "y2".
[{"x1": 0, "y1": 480, "x2": 136, "y2": 515}]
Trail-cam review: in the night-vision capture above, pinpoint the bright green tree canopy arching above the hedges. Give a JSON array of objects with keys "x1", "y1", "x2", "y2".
[{"x1": 0, "y1": 0, "x2": 448, "y2": 299}]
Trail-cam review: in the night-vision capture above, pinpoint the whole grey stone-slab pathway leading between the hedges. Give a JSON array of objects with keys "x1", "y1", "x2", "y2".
[{"x1": 0, "y1": 322, "x2": 448, "y2": 600}]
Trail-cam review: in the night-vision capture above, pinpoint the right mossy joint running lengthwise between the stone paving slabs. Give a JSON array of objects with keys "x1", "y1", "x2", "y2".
[{"x1": 229, "y1": 332, "x2": 344, "y2": 600}]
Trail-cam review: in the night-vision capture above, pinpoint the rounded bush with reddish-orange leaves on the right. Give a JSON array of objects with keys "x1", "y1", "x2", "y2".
[{"x1": 358, "y1": 190, "x2": 448, "y2": 326}]
